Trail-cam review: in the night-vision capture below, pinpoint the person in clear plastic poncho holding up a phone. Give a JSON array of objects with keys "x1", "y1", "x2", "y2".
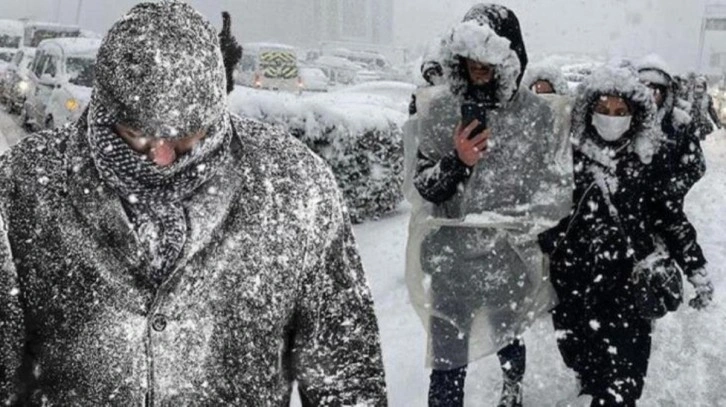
[{"x1": 406, "y1": 4, "x2": 571, "y2": 407}]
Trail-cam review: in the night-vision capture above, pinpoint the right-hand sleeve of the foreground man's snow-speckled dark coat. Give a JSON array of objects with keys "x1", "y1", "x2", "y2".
[{"x1": 293, "y1": 175, "x2": 387, "y2": 406}]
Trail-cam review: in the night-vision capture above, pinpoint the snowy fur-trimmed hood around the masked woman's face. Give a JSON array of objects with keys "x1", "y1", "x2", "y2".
[{"x1": 571, "y1": 65, "x2": 662, "y2": 164}]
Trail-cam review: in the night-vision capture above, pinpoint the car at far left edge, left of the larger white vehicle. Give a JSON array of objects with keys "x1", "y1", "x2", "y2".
[{"x1": 0, "y1": 48, "x2": 35, "y2": 113}]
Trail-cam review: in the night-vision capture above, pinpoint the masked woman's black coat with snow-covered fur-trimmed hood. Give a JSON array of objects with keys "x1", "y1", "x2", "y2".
[{"x1": 540, "y1": 66, "x2": 700, "y2": 315}]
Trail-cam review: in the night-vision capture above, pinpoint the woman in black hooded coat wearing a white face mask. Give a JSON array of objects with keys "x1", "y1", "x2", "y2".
[{"x1": 540, "y1": 67, "x2": 672, "y2": 406}]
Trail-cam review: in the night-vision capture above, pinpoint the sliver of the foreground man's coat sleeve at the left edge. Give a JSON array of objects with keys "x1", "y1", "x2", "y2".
[{"x1": 0, "y1": 212, "x2": 25, "y2": 405}]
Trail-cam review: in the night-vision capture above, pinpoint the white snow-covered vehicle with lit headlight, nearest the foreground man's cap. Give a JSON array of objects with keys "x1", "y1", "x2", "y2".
[{"x1": 22, "y1": 38, "x2": 101, "y2": 128}]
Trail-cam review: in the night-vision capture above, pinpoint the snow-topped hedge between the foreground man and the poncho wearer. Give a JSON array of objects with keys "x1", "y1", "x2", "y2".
[{"x1": 230, "y1": 88, "x2": 406, "y2": 223}]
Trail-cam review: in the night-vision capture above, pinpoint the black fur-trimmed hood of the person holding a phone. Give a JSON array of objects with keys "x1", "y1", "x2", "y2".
[{"x1": 441, "y1": 4, "x2": 528, "y2": 105}]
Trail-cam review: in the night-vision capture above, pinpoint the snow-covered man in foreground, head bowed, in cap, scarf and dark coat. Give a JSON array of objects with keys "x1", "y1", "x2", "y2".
[{"x1": 0, "y1": 1, "x2": 386, "y2": 406}]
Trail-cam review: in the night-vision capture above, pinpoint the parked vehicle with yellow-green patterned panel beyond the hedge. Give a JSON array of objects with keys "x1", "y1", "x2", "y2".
[{"x1": 235, "y1": 43, "x2": 303, "y2": 92}]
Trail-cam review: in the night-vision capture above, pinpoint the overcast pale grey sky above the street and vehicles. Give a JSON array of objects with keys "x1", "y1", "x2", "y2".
[{"x1": 0, "y1": 0, "x2": 726, "y2": 70}]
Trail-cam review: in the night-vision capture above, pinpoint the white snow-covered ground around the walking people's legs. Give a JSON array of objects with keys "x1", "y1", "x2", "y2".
[{"x1": 0, "y1": 107, "x2": 726, "y2": 407}]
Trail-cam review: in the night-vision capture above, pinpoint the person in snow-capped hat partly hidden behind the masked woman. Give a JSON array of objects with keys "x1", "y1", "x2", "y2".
[{"x1": 637, "y1": 55, "x2": 713, "y2": 308}]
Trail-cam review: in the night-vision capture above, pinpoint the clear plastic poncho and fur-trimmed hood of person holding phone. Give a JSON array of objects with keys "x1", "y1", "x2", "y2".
[{"x1": 404, "y1": 5, "x2": 571, "y2": 369}]
